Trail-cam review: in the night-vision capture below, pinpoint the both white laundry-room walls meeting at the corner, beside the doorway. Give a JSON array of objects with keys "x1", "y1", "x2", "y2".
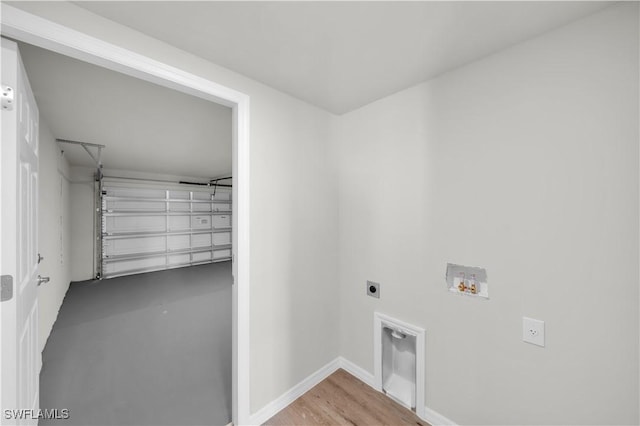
[{"x1": 14, "y1": 2, "x2": 639, "y2": 424}]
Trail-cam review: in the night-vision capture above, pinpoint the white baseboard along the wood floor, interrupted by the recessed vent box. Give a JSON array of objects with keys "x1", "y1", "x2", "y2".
[{"x1": 249, "y1": 356, "x2": 457, "y2": 426}]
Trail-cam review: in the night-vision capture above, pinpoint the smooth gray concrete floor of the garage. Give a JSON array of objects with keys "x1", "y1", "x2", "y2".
[{"x1": 40, "y1": 262, "x2": 231, "y2": 426}]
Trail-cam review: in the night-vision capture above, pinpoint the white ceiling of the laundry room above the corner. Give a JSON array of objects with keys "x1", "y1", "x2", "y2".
[{"x1": 74, "y1": 1, "x2": 611, "y2": 114}]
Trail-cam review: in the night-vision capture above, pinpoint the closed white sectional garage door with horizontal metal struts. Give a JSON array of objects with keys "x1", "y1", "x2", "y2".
[{"x1": 100, "y1": 179, "x2": 231, "y2": 278}]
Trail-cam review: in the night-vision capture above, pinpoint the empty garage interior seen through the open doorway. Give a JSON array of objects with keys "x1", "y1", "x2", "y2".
[{"x1": 19, "y1": 43, "x2": 232, "y2": 425}]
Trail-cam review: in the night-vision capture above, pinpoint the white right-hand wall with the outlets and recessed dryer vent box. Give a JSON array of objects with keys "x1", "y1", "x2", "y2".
[{"x1": 334, "y1": 3, "x2": 639, "y2": 424}]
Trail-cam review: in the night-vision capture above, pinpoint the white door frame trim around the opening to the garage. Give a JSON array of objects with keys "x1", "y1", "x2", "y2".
[{"x1": 1, "y1": 4, "x2": 250, "y2": 425}]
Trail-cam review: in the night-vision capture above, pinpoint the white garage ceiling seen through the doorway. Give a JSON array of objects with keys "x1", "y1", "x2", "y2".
[{"x1": 20, "y1": 43, "x2": 232, "y2": 178}]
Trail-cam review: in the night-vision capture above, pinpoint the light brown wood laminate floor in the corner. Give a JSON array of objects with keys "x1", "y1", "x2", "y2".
[{"x1": 265, "y1": 369, "x2": 428, "y2": 426}]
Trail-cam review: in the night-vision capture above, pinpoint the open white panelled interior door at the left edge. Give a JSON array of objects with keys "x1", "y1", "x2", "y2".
[{"x1": 0, "y1": 38, "x2": 42, "y2": 425}]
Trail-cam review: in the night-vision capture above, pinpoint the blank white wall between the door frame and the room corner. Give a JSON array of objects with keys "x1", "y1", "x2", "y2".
[{"x1": 7, "y1": 2, "x2": 338, "y2": 412}]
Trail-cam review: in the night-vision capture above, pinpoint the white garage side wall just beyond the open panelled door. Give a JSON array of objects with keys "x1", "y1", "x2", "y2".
[{"x1": 38, "y1": 117, "x2": 71, "y2": 352}]
